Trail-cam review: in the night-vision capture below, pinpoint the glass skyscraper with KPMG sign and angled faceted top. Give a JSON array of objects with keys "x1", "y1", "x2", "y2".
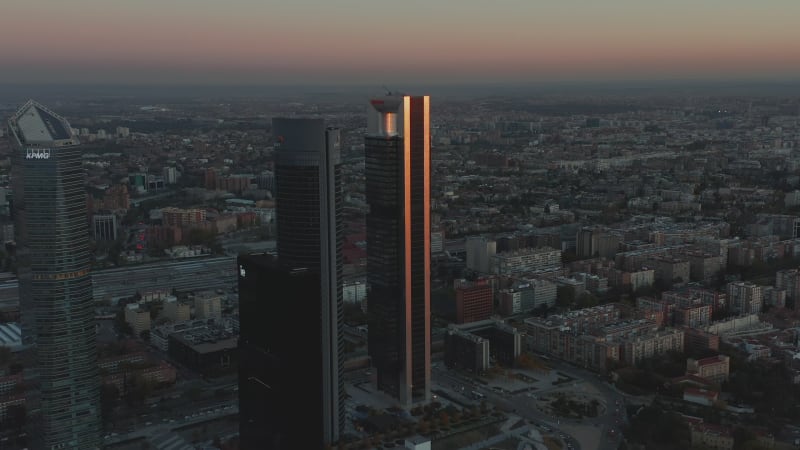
[{"x1": 9, "y1": 101, "x2": 100, "y2": 449}]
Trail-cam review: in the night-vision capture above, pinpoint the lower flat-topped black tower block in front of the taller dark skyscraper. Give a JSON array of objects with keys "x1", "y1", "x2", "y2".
[{"x1": 234, "y1": 255, "x2": 328, "y2": 450}]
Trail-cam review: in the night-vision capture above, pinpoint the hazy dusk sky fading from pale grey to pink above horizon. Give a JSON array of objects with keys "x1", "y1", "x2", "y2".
[{"x1": 0, "y1": 0, "x2": 800, "y2": 84}]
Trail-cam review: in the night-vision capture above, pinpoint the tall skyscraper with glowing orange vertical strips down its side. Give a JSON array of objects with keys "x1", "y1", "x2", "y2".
[{"x1": 365, "y1": 95, "x2": 431, "y2": 406}]
